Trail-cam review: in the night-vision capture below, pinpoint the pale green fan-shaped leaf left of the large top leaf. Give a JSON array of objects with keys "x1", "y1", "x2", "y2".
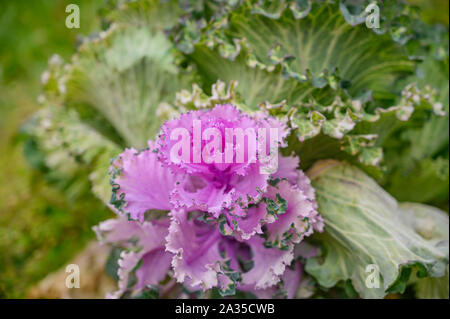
[{"x1": 64, "y1": 26, "x2": 189, "y2": 148}]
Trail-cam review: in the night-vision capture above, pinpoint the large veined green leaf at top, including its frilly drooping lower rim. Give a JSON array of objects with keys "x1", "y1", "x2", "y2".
[{"x1": 180, "y1": 1, "x2": 446, "y2": 178}]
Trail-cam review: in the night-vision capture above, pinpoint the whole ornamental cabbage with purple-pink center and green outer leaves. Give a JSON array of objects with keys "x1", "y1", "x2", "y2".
[{"x1": 26, "y1": 0, "x2": 449, "y2": 298}]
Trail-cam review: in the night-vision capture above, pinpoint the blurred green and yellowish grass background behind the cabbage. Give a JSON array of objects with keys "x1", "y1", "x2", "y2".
[{"x1": 0, "y1": 0, "x2": 449, "y2": 298}]
